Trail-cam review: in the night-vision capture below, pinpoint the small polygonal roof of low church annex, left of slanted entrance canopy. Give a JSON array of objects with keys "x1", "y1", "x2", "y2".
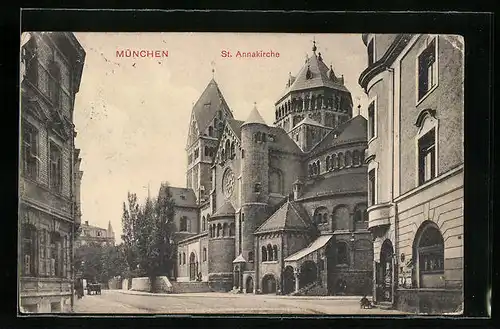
[{"x1": 255, "y1": 201, "x2": 312, "y2": 234}]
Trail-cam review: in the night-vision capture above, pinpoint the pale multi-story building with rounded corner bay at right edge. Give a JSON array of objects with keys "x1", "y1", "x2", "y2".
[{"x1": 359, "y1": 34, "x2": 464, "y2": 313}]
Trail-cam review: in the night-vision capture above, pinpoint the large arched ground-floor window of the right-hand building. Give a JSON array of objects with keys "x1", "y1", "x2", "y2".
[{"x1": 415, "y1": 221, "x2": 444, "y2": 288}]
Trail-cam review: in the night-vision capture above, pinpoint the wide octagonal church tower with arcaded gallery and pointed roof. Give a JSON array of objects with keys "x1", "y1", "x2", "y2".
[{"x1": 274, "y1": 41, "x2": 352, "y2": 152}]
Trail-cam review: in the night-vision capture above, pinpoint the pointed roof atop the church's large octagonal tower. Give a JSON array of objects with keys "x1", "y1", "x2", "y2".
[{"x1": 285, "y1": 52, "x2": 348, "y2": 95}]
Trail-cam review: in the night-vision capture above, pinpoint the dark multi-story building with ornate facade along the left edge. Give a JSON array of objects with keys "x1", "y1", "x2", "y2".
[{"x1": 18, "y1": 32, "x2": 85, "y2": 313}]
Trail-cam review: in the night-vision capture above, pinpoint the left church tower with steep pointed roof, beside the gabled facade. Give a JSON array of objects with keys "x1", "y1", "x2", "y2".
[{"x1": 186, "y1": 78, "x2": 233, "y2": 203}]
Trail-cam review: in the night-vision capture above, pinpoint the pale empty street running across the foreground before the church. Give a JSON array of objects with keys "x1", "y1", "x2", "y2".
[{"x1": 74, "y1": 290, "x2": 405, "y2": 315}]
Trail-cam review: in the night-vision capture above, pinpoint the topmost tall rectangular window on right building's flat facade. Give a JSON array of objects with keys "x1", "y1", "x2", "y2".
[{"x1": 418, "y1": 38, "x2": 437, "y2": 100}]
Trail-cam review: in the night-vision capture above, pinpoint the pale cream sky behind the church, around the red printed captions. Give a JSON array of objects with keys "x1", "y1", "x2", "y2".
[{"x1": 74, "y1": 33, "x2": 367, "y2": 241}]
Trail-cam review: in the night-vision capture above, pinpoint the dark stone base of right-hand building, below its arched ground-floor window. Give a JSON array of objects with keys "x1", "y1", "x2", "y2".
[{"x1": 396, "y1": 289, "x2": 463, "y2": 314}]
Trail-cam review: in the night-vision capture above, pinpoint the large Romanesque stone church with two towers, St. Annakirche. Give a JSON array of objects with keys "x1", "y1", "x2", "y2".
[{"x1": 171, "y1": 42, "x2": 373, "y2": 295}]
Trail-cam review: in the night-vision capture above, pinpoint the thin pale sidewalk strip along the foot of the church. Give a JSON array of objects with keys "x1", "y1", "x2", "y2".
[{"x1": 116, "y1": 289, "x2": 371, "y2": 300}]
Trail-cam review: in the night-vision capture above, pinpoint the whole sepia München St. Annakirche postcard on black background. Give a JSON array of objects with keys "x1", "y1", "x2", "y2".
[{"x1": 17, "y1": 31, "x2": 465, "y2": 316}]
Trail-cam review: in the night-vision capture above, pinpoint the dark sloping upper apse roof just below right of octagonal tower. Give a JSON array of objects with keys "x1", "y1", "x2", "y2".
[{"x1": 309, "y1": 115, "x2": 368, "y2": 154}]
